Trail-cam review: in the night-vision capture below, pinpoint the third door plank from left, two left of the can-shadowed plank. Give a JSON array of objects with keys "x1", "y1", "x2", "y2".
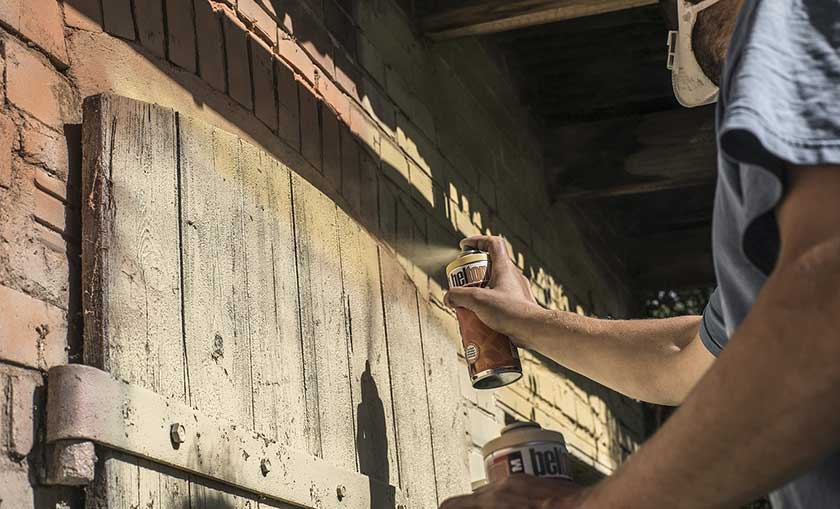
[{"x1": 242, "y1": 144, "x2": 306, "y2": 449}]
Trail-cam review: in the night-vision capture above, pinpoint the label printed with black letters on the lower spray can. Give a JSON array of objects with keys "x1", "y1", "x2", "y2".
[{"x1": 484, "y1": 442, "x2": 572, "y2": 482}]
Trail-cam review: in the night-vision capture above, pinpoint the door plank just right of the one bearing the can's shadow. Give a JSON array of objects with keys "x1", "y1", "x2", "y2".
[{"x1": 379, "y1": 252, "x2": 437, "y2": 508}]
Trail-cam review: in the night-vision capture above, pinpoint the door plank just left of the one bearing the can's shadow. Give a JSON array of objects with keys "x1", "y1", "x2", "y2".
[{"x1": 292, "y1": 175, "x2": 356, "y2": 470}]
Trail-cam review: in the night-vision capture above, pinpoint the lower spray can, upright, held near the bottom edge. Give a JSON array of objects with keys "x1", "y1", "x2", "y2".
[{"x1": 481, "y1": 422, "x2": 572, "y2": 483}]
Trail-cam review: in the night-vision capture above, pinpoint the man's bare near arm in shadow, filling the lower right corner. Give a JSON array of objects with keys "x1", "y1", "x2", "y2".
[{"x1": 580, "y1": 167, "x2": 840, "y2": 509}]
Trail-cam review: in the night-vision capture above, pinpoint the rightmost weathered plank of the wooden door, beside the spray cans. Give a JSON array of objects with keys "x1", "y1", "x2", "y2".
[{"x1": 420, "y1": 300, "x2": 470, "y2": 500}]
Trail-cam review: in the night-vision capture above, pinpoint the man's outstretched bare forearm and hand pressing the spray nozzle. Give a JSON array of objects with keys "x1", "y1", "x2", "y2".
[{"x1": 446, "y1": 236, "x2": 714, "y2": 405}]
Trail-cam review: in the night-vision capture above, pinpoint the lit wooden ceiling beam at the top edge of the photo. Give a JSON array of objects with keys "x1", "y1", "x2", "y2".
[{"x1": 420, "y1": 0, "x2": 658, "y2": 40}]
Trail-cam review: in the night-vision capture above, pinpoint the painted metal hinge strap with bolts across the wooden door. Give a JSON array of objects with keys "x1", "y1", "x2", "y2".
[{"x1": 47, "y1": 364, "x2": 405, "y2": 509}]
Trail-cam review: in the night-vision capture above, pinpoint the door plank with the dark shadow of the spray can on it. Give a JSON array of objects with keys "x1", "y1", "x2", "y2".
[{"x1": 338, "y1": 211, "x2": 399, "y2": 484}]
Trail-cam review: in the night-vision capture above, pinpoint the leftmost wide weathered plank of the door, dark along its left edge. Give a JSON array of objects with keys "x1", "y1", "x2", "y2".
[{"x1": 82, "y1": 95, "x2": 186, "y2": 507}]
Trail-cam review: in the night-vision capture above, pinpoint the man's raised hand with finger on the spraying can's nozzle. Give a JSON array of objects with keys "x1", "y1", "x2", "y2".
[{"x1": 445, "y1": 235, "x2": 543, "y2": 339}]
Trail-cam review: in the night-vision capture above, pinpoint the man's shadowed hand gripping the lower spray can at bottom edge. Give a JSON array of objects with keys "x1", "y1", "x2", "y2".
[{"x1": 440, "y1": 475, "x2": 588, "y2": 509}]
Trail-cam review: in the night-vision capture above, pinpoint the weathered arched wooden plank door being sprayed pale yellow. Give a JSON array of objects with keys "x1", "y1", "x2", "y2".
[{"x1": 83, "y1": 95, "x2": 468, "y2": 509}]
